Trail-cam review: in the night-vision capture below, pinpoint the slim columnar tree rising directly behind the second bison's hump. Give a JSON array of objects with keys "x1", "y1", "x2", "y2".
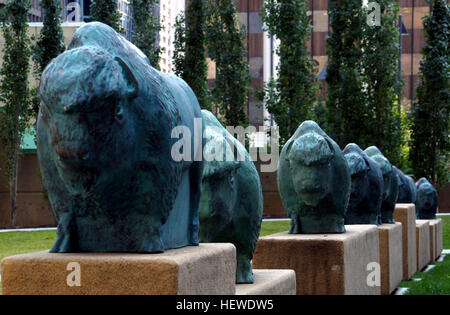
[{"x1": 206, "y1": 0, "x2": 250, "y2": 126}]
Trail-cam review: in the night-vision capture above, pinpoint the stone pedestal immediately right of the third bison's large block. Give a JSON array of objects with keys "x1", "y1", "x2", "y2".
[{"x1": 378, "y1": 222, "x2": 403, "y2": 295}]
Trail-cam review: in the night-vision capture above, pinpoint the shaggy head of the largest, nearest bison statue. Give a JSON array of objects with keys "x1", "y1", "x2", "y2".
[{"x1": 38, "y1": 46, "x2": 138, "y2": 194}]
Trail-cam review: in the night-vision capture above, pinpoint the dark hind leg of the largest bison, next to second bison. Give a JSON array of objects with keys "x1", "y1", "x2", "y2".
[{"x1": 189, "y1": 162, "x2": 203, "y2": 245}]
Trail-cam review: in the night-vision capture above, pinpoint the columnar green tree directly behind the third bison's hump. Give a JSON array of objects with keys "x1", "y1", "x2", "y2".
[{"x1": 261, "y1": 0, "x2": 318, "y2": 143}]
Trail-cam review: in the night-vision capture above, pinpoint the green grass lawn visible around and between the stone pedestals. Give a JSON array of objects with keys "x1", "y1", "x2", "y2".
[{"x1": 0, "y1": 216, "x2": 450, "y2": 294}]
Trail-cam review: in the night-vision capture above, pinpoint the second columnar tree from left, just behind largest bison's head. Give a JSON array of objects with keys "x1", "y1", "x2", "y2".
[{"x1": 31, "y1": 0, "x2": 66, "y2": 119}]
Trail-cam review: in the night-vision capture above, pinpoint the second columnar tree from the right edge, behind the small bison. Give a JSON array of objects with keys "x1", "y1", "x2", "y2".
[{"x1": 362, "y1": 0, "x2": 405, "y2": 167}]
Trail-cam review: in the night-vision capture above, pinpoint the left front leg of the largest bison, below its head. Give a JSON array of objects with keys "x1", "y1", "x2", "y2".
[{"x1": 50, "y1": 213, "x2": 79, "y2": 253}]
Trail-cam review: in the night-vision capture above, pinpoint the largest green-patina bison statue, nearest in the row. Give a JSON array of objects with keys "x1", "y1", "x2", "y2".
[{"x1": 37, "y1": 22, "x2": 203, "y2": 253}]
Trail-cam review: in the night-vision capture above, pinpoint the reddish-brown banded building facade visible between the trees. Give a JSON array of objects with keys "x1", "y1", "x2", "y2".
[{"x1": 187, "y1": 0, "x2": 430, "y2": 126}]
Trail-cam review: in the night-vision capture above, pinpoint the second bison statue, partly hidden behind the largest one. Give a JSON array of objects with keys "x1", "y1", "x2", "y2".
[{"x1": 199, "y1": 110, "x2": 263, "y2": 283}]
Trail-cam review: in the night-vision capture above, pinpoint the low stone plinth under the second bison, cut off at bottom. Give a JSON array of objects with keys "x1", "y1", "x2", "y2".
[{"x1": 236, "y1": 269, "x2": 296, "y2": 295}]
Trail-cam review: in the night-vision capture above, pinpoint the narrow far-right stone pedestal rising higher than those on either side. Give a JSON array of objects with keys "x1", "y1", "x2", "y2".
[{"x1": 394, "y1": 203, "x2": 417, "y2": 280}]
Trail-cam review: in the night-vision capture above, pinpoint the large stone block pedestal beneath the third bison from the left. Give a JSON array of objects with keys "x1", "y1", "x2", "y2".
[{"x1": 253, "y1": 225, "x2": 381, "y2": 294}]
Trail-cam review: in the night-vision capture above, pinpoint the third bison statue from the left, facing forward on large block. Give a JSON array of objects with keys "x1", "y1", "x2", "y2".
[{"x1": 278, "y1": 121, "x2": 351, "y2": 234}]
